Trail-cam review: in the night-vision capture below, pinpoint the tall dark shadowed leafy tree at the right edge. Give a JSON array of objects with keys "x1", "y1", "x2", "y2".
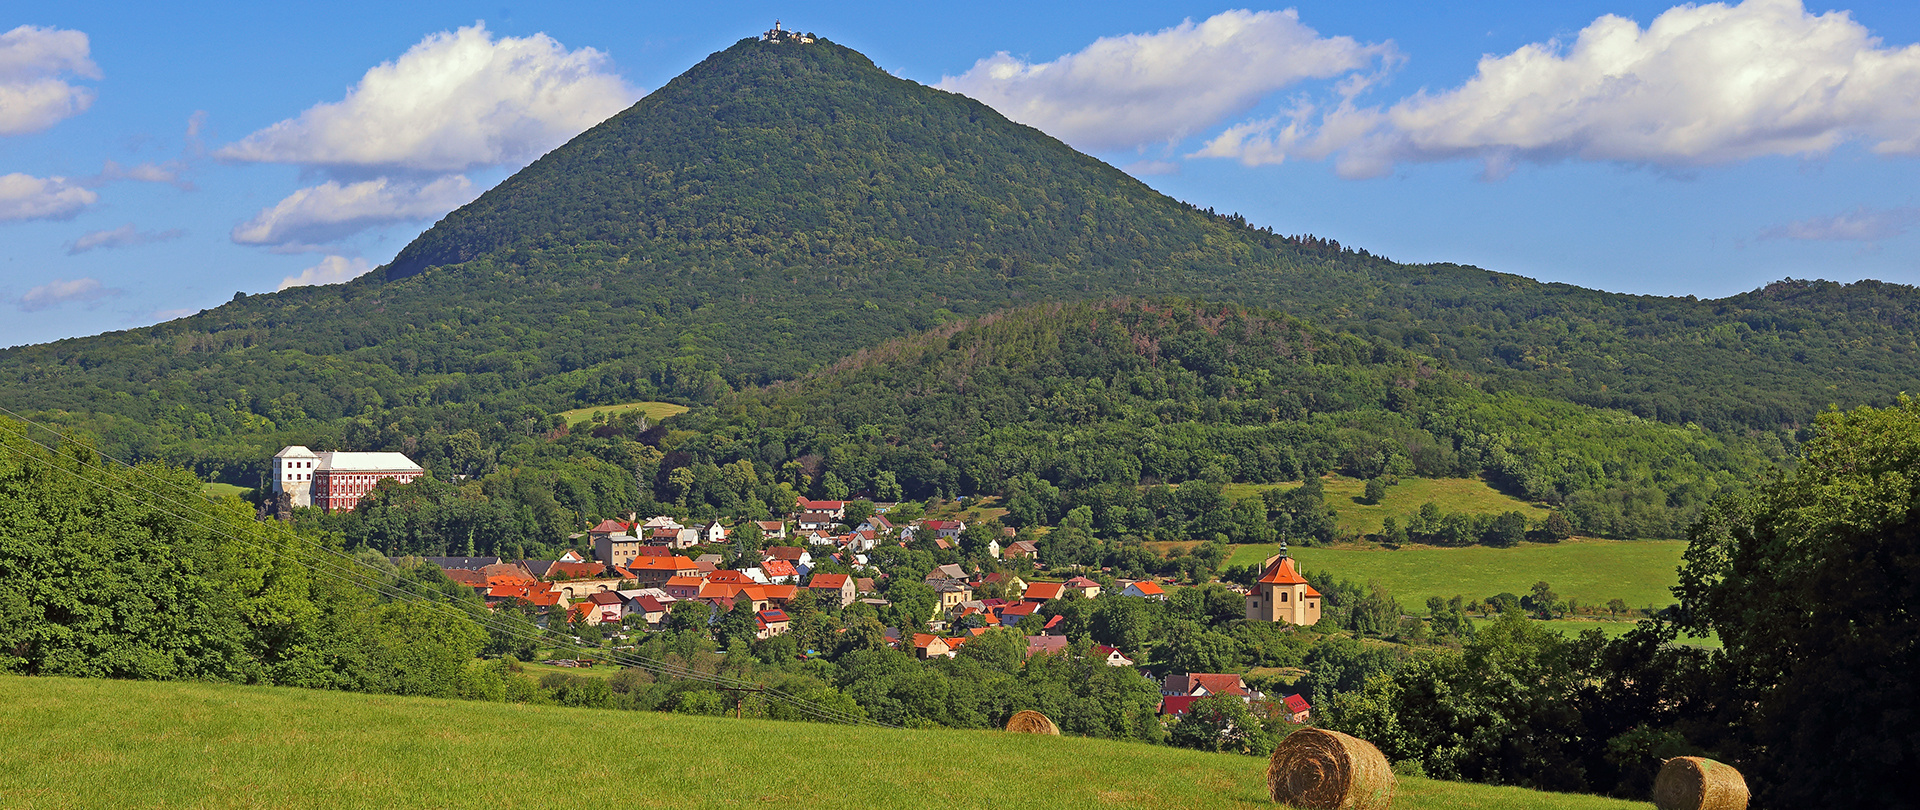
[{"x1": 1676, "y1": 397, "x2": 1920, "y2": 806}]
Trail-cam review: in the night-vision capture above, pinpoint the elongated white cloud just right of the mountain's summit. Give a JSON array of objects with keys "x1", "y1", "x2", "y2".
[{"x1": 939, "y1": 10, "x2": 1396, "y2": 150}]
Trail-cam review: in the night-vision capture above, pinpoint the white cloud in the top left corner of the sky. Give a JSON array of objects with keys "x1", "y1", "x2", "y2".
[{"x1": 0, "y1": 25, "x2": 100, "y2": 134}]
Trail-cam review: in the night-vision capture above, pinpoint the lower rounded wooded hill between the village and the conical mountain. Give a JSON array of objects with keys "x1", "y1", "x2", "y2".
[{"x1": 664, "y1": 299, "x2": 1786, "y2": 543}]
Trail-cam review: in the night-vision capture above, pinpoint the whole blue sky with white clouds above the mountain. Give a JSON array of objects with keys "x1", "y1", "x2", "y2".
[{"x1": 0, "y1": 0, "x2": 1920, "y2": 345}]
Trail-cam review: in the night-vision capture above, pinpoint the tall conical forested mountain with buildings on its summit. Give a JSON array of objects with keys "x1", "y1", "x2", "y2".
[{"x1": 0, "y1": 33, "x2": 1920, "y2": 480}]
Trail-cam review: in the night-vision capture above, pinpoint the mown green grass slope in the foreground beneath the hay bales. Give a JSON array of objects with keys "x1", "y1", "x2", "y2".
[{"x1": 0, "y1": 676, "x2": 1649, "y2": 810}]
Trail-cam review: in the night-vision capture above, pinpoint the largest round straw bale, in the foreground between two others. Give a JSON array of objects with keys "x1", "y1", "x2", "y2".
[{"x1": 1267, "y1": 727, "x2": 1396, "y2": 810}]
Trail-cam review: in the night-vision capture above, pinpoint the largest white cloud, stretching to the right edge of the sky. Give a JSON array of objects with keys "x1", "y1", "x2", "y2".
[{"x1": 1196, "y1": 0, "x2": 1920, "y2": 177}]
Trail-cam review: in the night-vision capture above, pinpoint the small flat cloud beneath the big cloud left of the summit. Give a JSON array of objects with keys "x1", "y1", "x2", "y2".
[{"x1": 232, "y1": 175, "x2": 478, "y2": 250}]
